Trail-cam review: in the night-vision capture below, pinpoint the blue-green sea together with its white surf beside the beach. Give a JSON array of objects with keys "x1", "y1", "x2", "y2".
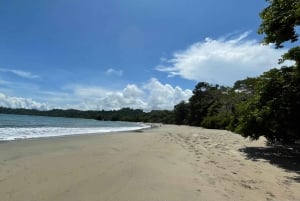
[{"x1": 0, "y1": 114, "x2": 149, "y2": 141}]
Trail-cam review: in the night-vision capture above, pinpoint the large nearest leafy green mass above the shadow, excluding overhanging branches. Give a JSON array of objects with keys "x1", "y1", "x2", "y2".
[{"x1": 235, "y1": 67, "x2": 300, "y2": 143}]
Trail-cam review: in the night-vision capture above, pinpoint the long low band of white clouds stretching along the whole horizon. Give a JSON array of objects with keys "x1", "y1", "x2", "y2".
[{"x1": 0, "y1": 78, "x2": 192, "y2": 111}]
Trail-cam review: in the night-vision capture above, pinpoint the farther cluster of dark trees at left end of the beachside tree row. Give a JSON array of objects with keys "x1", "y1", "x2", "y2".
[{"x1": 174, "y1": 82, "x2": 235, "y2": 129}]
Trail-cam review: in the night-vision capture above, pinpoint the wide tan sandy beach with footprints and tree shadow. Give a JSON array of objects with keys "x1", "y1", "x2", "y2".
[{"x1": 0, "y1": 125, "x2": 300, "y2": 201}]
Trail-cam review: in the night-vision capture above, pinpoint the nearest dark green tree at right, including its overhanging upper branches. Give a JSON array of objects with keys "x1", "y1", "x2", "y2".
[{"x1": 235, "y1": 0, "x2": 300, "y2": 143}]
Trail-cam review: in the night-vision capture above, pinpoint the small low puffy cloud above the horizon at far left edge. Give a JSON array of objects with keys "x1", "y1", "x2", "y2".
[{"x1": 0, "y1": 93, "x2": 49, "y2": 110}]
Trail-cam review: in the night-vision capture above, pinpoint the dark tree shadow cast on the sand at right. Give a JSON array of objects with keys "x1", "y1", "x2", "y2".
[{"x1": 239, "y1": 146, "x2": 300, "y2": 183}]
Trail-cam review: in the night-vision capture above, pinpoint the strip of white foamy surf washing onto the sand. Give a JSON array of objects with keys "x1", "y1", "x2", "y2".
[{"x1": 0, "y1": 124, "x2": 149, "y2": 141}]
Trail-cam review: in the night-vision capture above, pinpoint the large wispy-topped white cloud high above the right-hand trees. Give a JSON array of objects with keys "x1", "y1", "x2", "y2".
[{"x1": 157, "y1": 32, "x2": 292, "y2": 85}]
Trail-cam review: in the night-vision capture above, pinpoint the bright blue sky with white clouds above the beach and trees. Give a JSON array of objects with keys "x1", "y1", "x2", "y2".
[{"x1": 0, "y1": 0, "x2": 294, "y2": 111}]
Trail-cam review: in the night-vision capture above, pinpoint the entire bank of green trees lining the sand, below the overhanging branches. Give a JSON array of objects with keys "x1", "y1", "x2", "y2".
[{"x1": 174, "y1": 66, "x2": 300, "y2": 144}]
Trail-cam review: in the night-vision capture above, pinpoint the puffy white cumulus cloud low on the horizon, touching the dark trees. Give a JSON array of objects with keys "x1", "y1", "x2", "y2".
[{"x1": 75, "y1": 78, "x2": 192, "y2": 111}]
